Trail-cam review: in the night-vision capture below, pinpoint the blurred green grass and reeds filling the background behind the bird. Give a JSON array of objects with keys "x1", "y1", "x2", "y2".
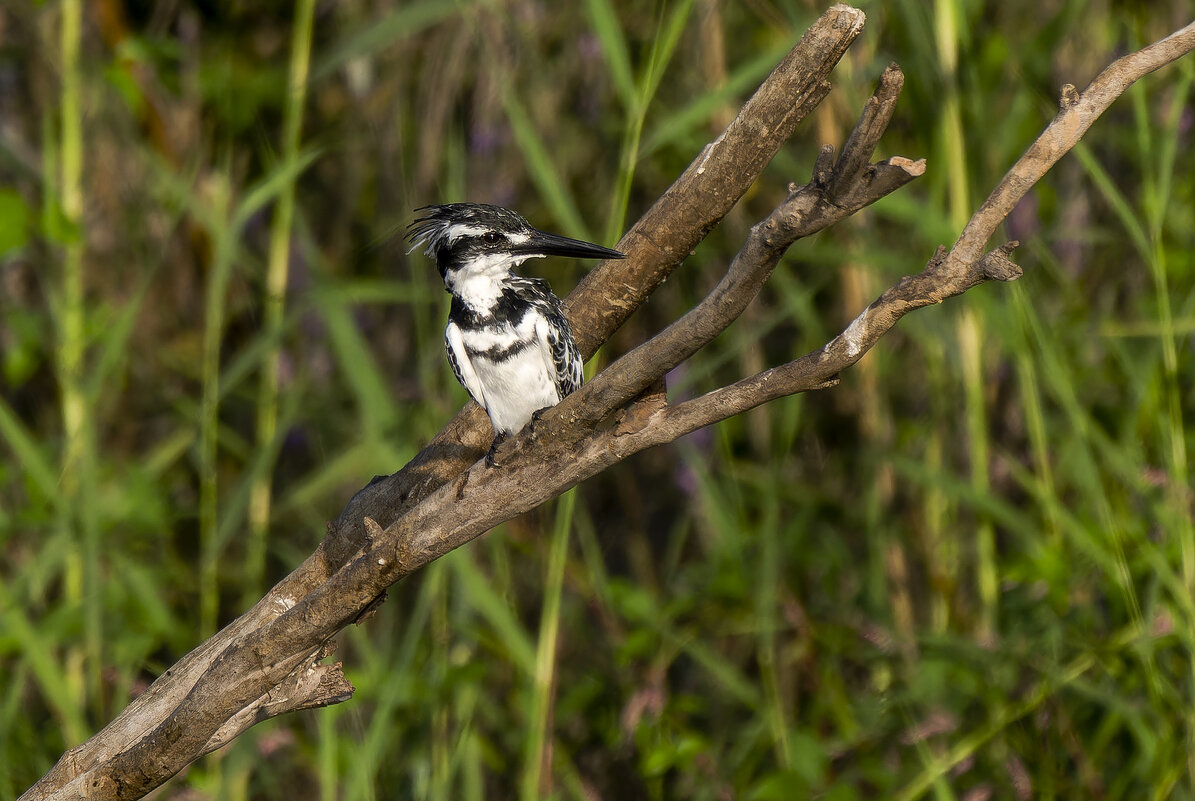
[{"x1": 0, "y1": 0, "x2": 1195, "y2": 801}]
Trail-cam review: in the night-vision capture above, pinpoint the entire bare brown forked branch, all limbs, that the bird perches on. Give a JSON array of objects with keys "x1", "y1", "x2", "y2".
[{"x1": 22, "y1": 6, "x2": 1195, "y2": 801}]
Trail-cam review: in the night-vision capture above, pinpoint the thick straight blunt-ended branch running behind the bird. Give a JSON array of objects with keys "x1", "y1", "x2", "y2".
[{"x1": 23, "y1": 5, "x2": 864, "y2": 799}]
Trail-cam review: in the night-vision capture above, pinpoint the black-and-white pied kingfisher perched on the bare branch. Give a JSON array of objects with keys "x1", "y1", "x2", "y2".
[{"x1": 406, "y1": 203, "x2": 624, "y2": 467}]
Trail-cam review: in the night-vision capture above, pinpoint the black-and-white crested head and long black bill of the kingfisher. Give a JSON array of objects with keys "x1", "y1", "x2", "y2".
[{"x1": 406, "y1": 203, "x2": 625, "y2": 292}]
